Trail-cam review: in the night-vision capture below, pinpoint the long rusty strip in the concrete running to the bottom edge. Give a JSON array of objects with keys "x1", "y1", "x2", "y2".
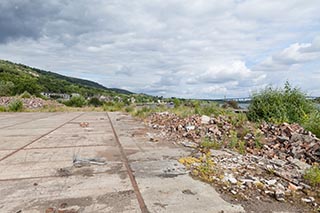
[{"x1": 107, "y1": 113, "x2": 149, "y2": 213}]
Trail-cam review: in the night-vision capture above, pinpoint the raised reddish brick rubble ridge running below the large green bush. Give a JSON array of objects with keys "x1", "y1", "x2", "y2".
[{"x1": 149, "y1": 112, "x2": 320, "y2": 165}]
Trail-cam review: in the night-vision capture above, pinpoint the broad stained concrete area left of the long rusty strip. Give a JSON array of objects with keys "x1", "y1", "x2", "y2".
[{"x1": 0, "y1": 113, "x2": 140, "y2": 212}]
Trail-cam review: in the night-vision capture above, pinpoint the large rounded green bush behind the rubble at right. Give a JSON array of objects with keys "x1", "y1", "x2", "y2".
[{"x1": 248, "y1": 82, "x2": 316, "y2": 123}]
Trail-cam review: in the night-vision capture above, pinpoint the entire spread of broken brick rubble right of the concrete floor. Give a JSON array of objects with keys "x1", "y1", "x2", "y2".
[{"x1": 147, "y1": 112, "x2": 320, "y2": 207}]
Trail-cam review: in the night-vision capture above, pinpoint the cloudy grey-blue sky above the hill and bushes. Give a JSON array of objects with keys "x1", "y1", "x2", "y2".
[{"x1": 0, "y1": 0, "x2": 320, "y2": 99}]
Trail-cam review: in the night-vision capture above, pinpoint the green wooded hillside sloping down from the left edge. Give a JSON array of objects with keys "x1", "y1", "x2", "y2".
[{"x1": 0, "y1": 60, "x2": 133, "y2": 96}]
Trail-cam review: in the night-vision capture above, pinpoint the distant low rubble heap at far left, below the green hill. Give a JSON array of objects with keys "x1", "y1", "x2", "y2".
[{"x1": 0, "y1": 97, "x2": 63, "y2": 109}]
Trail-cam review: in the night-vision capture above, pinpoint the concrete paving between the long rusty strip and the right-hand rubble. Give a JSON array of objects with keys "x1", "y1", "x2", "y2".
[{"x1": 110, "y1": 113, "x2": 244, "y2": 212}]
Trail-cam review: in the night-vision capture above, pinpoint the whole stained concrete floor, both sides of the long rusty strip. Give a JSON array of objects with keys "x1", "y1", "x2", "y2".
[{"x1": 0, "y1": 112, "x2": 244, "y2": 213}]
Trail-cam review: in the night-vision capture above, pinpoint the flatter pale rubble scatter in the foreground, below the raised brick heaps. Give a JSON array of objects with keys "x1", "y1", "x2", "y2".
[{"x1": 187, "y1": 150, "x2": 318, "y2": 207}]
